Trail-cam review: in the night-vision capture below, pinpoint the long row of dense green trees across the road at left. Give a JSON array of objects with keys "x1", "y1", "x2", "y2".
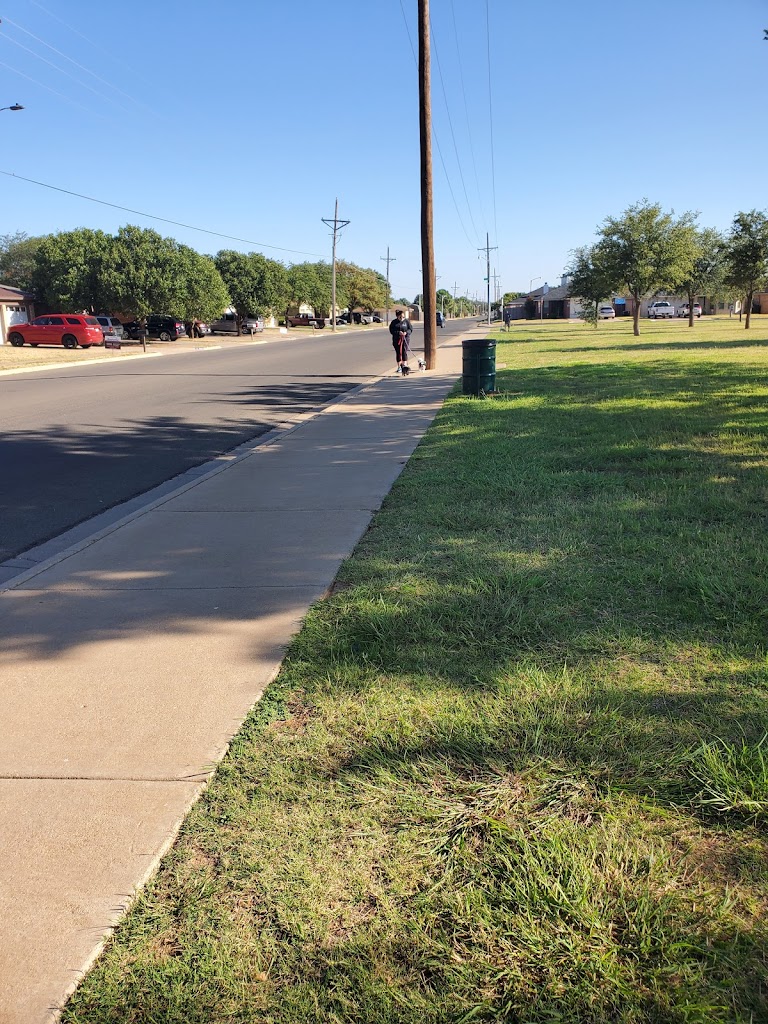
[{"x1": 0, "y1": 225, "x2": 387, "y2": 321}]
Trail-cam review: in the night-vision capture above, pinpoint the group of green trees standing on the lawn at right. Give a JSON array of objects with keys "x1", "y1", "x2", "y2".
[{"x1": 567, "y1": 200, "x2": 768, "y2": 335}]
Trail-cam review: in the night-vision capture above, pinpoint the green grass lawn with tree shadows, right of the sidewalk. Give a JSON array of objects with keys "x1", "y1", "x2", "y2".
[{"x1": 63, "y1": 317, "x2": 768, "y2": 1024}]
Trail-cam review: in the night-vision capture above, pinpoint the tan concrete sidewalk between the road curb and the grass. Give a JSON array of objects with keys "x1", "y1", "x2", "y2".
[{"x1": 0, "y1": 332, "x2": 466, "y2": 1024}]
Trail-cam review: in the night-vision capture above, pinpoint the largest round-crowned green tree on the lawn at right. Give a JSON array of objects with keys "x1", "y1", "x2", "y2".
[{"x1": 598, "y1": 200, "x2": 693, "y2": 336}]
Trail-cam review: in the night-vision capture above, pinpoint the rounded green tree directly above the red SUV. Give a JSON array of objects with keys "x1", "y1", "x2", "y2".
[{"x1": 32, "y1": 227, "x2": 114, "y2": 312}]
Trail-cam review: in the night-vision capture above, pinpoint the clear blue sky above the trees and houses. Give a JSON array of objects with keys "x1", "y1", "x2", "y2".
[{"x1": 0, "y1": 0, "x2": 768, "y2": 297}]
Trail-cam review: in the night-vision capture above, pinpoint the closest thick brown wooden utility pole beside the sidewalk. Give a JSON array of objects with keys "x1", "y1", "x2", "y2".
[{"x1": 419, "y1": 0, "x2": 437, "y2": 370}]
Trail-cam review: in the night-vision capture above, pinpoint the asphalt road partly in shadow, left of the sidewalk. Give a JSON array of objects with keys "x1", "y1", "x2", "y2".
[{"x1": 0, "y1": 322, "x2": 467, "y2": 562}]
